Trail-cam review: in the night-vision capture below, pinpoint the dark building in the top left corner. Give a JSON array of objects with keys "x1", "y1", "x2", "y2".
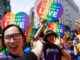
[{"x1": 0, "y1": 0, "x2": 11, "y2": 21}]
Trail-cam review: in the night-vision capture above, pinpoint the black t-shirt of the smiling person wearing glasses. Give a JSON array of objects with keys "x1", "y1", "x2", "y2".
[{"x1": 0, "y1": 52, "x2": 37, "y2": 60}]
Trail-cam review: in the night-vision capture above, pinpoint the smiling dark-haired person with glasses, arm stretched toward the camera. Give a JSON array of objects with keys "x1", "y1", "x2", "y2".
[{"x1": 0, "y1": 24, "x2": 43, "y2": 60}]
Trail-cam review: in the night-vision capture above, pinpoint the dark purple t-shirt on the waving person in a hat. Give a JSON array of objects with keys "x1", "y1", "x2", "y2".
[{"x1": 43, "y1": 45, "x2": 61, "y2": 60}]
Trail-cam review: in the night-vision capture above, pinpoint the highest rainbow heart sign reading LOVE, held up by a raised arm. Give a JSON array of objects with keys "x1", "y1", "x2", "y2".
[{"x1": 36, "y1": 0, "x2": 63, "y2": 23}]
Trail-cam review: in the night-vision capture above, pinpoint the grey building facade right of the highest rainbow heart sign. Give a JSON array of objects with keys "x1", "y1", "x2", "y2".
[{"x1": 60, "y1": 0, "x2": 80, "y2": 30}]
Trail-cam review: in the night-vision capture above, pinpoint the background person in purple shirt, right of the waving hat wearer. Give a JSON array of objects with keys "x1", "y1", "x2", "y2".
[{"x1": 66, "y1": 37, "x2": 78, "y2": 60}]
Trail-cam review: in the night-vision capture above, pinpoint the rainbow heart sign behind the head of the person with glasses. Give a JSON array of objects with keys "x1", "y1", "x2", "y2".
[{"x1": 1, "y1": 12, "x2": 30, "y2": 32}]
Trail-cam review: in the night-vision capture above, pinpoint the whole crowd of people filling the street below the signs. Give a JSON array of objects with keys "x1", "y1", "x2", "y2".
[{"x1": 0, "y1": 20, "x2": 80, "y2": 60}]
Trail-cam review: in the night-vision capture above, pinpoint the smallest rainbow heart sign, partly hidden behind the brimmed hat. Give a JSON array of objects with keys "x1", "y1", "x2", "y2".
[{"x1": 48, "y1": 22, "x2": 65, "y2": 37}]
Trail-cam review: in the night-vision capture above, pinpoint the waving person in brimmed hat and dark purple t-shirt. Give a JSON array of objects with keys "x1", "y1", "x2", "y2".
[{"x1": 43, "y1": 28, "x2": 70, "y2": 60}]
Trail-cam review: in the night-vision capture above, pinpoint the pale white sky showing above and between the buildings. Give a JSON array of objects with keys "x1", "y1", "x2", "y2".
[{"x1": 10, "y1": 0, "x2": 80, "y2": 14}]
